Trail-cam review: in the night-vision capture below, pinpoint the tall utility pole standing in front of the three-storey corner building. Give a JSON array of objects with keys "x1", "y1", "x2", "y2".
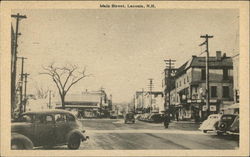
[{"x1": 200, "y1": 34, "x2": 213, "y2": 116}]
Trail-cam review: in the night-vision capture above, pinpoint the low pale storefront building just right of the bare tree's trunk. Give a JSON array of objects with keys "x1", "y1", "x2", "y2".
[{"x1": 57, "y1": 90, "x2": 112, "y2": 118}]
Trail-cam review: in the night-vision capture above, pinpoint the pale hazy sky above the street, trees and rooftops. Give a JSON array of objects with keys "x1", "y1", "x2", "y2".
[{"x1": 12, "y1": 9, "x2": 239, "y2": 102}]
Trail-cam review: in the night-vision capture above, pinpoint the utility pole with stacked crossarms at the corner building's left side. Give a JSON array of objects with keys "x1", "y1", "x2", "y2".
[{"x1": 164, "y1": 59, "x2": 176, "y2": 114}]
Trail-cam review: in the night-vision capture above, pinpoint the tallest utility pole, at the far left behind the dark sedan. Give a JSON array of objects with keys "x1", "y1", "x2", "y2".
[{"x1": 11, "y1": 13, "x2": 27, "y2": 115}]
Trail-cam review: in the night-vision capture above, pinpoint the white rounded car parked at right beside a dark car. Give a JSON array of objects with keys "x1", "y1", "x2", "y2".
[{"x1": 199, "y1": 114, "x2": 222, "y2": 133}]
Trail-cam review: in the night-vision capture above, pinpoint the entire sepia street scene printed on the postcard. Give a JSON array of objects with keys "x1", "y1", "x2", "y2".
[{"x1": 1, "y1": 1, "x2": 249, "y2": 155}]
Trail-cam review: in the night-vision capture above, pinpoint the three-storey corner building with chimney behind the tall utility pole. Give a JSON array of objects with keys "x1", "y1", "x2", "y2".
[{"x1": 165, "y1": 51, "x2": 233, "y2": 119}]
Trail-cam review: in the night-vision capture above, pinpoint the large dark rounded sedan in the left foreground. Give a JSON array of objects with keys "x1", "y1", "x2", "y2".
[{"x1": 11, "y1": 110, "x2": 88, "y2": 149}]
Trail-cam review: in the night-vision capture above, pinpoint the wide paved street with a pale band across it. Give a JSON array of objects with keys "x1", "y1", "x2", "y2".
[{"x1": 46, "y1": 119, "x2": 239, "y2": 150}]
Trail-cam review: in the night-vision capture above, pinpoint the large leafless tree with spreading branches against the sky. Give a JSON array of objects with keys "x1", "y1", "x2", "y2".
[{"x1": 40, "y1": 63, "x2": 90, "y2": 109}]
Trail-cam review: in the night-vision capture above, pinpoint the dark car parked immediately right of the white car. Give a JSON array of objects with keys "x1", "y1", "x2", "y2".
[{"x1": 216, "y1": 114, "x2": 238, "y2": 135}]
